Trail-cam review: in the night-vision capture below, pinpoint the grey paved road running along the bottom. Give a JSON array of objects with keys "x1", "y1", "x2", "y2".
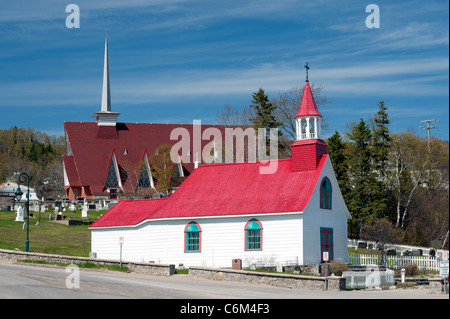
[{"x1": 0, "y1": 263, "x2": 448, "y2": 299}]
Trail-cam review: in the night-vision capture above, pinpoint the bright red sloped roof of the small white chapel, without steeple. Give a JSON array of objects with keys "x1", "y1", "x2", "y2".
[{"x1": 91, "y1": 154, "x2": 328, "y2": 228}]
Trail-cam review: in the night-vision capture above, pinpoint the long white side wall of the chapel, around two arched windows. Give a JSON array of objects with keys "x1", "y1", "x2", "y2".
[{"x1": 92, "y1": 213, "x2": 302, "y2": 267}]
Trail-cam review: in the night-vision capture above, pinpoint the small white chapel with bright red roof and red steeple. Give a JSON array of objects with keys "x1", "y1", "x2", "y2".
[{"x1": 90, "y1": 82, "x2": 351, "y2": 267}]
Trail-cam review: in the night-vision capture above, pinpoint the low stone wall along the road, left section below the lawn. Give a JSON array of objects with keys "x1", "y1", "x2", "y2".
[{"x1": 0, "y1": 249, "x2": 175, "y2": 276}]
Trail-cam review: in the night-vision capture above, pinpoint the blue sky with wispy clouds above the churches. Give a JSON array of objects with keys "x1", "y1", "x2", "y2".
[{"x1": 0, "y1": 0, "x2": 449, "y2": 140}]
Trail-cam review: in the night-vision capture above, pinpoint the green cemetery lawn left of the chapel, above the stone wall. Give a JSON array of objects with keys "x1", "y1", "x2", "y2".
[{"x1": 0, "y1": 210, "x2": 105, "y2": 257}]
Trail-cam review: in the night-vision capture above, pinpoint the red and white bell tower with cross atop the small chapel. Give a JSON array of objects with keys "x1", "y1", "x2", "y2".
[{"x1": 292, "y1": 62, "x2": 327, "y2": 172}]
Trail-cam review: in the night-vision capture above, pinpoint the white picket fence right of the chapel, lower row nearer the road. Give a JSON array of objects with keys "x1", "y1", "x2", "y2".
[{"x1": 349, "y1": 255, "x2": 441, "y2": 271}]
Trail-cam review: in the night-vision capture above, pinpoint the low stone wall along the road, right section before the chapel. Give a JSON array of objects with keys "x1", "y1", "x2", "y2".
[{"x1": 189, "y1": 267, "x2": 345, "y2": 291}]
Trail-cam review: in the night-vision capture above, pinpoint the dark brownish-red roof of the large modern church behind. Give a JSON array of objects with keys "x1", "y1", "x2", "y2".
[{"x1": 63, "y1": 122, "x2": 237, "y2": 194}]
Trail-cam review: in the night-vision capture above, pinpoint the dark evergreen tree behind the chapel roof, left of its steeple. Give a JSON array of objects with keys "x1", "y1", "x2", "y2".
[{"x1": 250, "y1": 88, "x2": 283, "y2": 158}]
